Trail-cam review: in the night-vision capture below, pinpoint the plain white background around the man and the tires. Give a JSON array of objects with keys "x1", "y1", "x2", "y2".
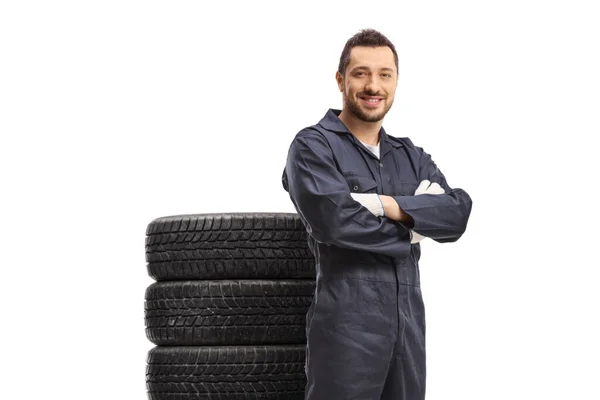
[{"x1": 0, "y1": 0, "x2": 600, "y2": 400}]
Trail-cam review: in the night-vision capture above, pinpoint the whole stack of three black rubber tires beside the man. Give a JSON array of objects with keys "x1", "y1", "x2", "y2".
[{"x1": 145, "y1": 213, "x2": 315, "y2": 400}]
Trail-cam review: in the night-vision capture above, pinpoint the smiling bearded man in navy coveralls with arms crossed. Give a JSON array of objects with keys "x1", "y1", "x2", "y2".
[{"x1": 283, "y1": 29, "x2": 471, "y2": 400}]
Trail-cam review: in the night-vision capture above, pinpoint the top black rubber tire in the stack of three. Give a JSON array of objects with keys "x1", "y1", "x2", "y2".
[{"x1": 146, "y1": 213, "x2": 315, "y2": 281}]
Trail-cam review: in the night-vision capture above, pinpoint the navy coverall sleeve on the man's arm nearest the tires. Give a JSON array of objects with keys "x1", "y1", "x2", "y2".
[{"x1": 285, "y1": 131, "x2": 410, "y2": 257}]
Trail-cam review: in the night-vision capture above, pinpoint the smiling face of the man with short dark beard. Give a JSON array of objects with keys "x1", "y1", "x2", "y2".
[{"x1": 336, "y1": 46, "x2": 398, "y2": 122}]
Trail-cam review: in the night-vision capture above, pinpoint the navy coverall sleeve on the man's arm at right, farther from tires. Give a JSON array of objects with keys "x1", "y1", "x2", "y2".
[{"x1": 393, "y1": 147, "x2": 472, "y2": 243}]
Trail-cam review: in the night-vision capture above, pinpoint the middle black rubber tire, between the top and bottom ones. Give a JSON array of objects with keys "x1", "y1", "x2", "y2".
[{"x1": 145, "y1": 279, "x2": 315, "y2": 346}]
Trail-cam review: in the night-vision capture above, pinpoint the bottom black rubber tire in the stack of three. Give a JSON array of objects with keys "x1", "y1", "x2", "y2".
[{"x1": 146, "y1": 345, "x2": 306, "y2": 400}]
